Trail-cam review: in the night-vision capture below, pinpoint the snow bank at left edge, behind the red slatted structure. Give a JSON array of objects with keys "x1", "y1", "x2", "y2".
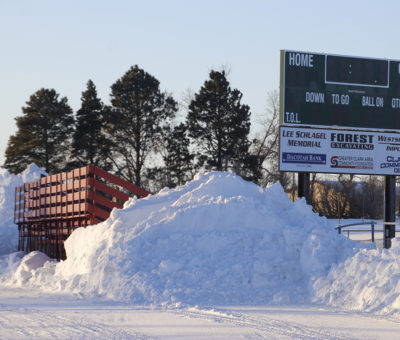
[{"x1": 0, "y1": 164, "x2": 47, "y2": 255}]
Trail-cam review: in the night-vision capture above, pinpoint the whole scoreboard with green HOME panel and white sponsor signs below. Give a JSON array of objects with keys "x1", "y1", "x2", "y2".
[{"x1": 280, "y1": 51, "x2": 400, "y2": 175}]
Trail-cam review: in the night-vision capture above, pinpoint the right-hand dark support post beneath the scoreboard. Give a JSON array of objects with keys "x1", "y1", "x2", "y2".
[{"x1": 383, "y1": 175, "x2": 396, "y2": 249}]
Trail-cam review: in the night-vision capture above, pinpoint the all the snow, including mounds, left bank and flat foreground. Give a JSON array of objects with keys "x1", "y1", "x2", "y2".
[{"x1": 0, "y1": 166, "x2": 400, "y2": 339}]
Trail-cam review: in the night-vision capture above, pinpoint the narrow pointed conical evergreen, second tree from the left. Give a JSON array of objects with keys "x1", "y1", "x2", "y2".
[{"x1": 70, "y1": 80, "x2": 111, "y2": 170}]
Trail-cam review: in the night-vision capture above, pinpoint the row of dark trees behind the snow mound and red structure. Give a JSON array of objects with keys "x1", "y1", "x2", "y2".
[{"x1": 3, "y1": 65, "x2": 287, "y2": 191}]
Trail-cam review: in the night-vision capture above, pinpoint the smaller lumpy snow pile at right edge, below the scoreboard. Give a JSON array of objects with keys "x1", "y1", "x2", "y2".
[{"x1": 314, "y1": 239, "x2": 400, "y2": 314}]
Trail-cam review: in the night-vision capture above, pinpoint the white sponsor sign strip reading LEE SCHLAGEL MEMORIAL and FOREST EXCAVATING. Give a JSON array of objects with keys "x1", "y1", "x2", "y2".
[{"x1": 280, "y1": 126, "x2": 400, "y2": 175}]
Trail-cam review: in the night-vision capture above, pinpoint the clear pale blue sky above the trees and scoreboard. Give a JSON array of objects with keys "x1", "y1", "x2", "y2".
[{"x1": 0, "y1": 0, "x2": 400, "y2": 163}]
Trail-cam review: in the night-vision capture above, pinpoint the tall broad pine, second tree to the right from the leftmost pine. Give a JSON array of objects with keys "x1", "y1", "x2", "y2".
[{"x1": 107, "y1": 65, "x2": 177, "y2": 186}]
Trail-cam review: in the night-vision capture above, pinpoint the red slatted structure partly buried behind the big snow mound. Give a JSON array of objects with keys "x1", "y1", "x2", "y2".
[{"x1": 14, "y1": 165, "x2": 149, "y2": 260}]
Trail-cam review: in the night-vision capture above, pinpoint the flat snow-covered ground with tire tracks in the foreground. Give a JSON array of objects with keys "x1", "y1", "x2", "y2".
[{"x1": 0, "y1": 288, "x2": 400, "y2": 340}]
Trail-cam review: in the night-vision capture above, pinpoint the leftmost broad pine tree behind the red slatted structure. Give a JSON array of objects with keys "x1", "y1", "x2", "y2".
[{"x1": 3, "y1": 88, "x2": 74, "y2": 174}]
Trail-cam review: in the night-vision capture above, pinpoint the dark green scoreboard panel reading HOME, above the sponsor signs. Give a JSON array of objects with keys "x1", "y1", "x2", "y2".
[{"x1": 280, "y1": 50, "x2": 400, "y2": 131}]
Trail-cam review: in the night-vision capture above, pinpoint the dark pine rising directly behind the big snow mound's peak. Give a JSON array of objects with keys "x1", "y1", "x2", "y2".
[{"x1": 187, "y1": 71, "x2": 250, "y2": 173}]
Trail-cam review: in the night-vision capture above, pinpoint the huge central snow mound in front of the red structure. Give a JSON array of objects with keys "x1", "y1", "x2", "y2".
[{"x1": 3, "y1": 172, "x2": 361, "y2": 305}]
